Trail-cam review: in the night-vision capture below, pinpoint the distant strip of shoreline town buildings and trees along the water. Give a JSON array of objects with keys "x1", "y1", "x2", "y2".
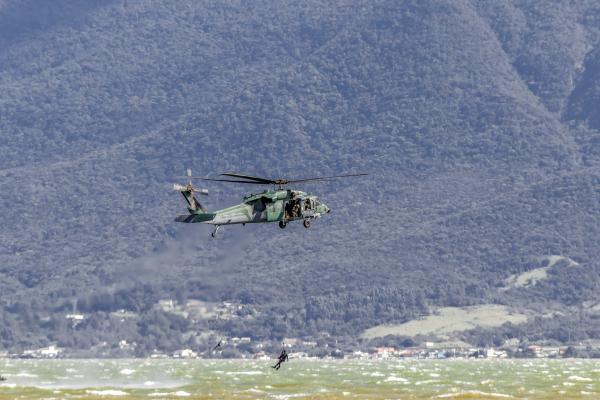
[{"x1": 0, "y1": 337, "x2": 600, "y2": 360}]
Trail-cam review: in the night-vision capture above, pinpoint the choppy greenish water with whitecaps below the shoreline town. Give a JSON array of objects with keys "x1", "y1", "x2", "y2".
[{"x1": 0, "y1": 359, "x2": 600, "y2": 400}]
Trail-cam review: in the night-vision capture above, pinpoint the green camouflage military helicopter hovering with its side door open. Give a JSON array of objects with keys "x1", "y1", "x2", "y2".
[{"x1": 173, "y1": 169, "x2": 367, "y2": 238}]
